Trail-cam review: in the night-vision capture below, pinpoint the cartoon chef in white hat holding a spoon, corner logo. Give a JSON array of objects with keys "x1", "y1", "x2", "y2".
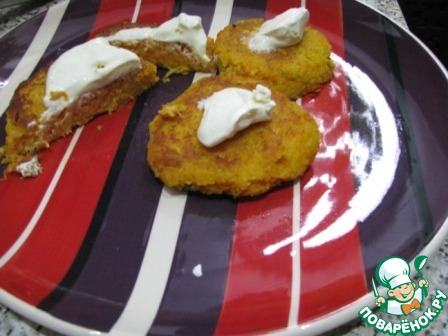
[{"x1": 372, "y1": 256, "x2": 429, "y2": 316}]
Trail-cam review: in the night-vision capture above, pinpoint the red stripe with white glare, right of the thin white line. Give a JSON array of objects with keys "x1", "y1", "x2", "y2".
[{"x1": 298, "y1": 0, "x2": 367, "y2": 323}]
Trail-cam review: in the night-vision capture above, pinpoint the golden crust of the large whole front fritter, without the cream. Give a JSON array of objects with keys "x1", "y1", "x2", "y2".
[{"x1": 147, "y1": 75, "x2": 320, "y2": 197}]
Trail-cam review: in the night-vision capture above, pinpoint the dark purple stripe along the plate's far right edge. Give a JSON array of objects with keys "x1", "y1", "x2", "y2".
[{"x1": 385, "y1": 17, "x2": 448, "y2": 239}]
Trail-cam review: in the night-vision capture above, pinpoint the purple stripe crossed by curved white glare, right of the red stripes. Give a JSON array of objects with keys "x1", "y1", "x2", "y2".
[{"x1": 343, "y1": 1, "x2": 423, "y2": 278}]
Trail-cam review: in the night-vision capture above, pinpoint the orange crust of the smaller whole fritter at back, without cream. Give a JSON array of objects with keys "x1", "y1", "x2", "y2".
[{"x1": 215, "y1": 19, "x2": 334, "y2": 99}]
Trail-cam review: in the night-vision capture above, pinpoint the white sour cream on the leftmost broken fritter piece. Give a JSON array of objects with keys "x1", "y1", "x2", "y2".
[{"x1": 41, "y1": 37, "x2": 141, "y2": 121}]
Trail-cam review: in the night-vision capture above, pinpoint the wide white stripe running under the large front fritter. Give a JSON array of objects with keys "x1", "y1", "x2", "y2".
[{"x1": 109, "y1": 0, "x2": 233, "y2": 335}]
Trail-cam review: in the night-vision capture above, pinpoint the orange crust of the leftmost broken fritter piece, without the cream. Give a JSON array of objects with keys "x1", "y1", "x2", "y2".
[{"x1": 2, "y1": 61, "x2": 159, "y2": 172}]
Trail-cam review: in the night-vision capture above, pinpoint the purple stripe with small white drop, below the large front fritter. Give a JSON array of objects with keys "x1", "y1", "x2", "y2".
[{"x1": 148, "y1": 0, "x2": 265, "y2": 335}]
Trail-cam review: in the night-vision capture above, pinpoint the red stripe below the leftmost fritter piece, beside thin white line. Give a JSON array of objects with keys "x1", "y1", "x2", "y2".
[{"x1": 0, "y1": 0, "x2": 172, "y2": 305}]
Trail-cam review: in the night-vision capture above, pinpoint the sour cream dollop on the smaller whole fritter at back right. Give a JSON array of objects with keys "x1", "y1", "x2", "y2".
[{"x1": 249, "y1": 7, "x2": 310, "y2": 52}]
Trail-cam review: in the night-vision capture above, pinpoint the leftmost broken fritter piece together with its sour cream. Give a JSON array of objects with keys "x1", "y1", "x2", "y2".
[{"x1": 0, "y1": 39, "x2": 159, "y2": 177}]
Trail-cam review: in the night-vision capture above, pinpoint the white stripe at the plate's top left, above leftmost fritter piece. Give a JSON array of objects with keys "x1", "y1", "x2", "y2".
[{"x1": 0, "y1": 1, "x2": 69, "y2": 117}]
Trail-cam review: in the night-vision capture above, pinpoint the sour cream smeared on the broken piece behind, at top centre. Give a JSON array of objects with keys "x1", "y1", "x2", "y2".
[{"x1": 108, "y1": 13, "x2": 210, "y2": 62}]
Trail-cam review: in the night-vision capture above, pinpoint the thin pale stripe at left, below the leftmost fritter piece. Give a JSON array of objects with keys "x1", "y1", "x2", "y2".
[{"x1": 0, "y1": 128, "x2": 82, "y2": 268}]
